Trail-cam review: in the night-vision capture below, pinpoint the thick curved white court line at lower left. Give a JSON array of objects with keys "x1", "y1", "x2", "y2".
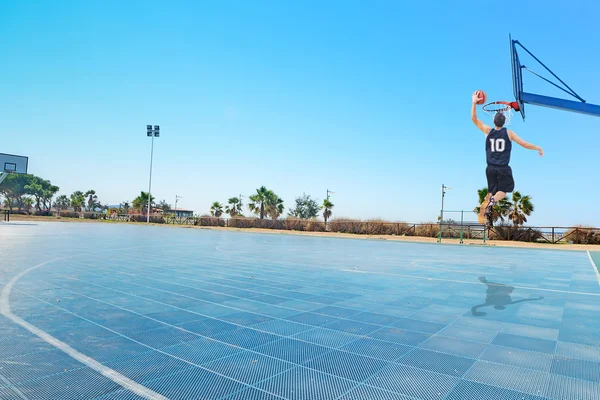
[{"x1": 0, "y1": 256, "x2": 168, "y2": 400}]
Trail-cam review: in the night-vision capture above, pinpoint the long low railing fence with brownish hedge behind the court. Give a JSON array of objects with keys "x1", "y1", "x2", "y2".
[{"x1": 5, "y1": 211, "x2": 600, "y2": 245}]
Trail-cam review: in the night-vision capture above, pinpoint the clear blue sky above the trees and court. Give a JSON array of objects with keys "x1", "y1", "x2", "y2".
[{"x1": 0, "y1": 0, "x2": 600, "y2": 226}]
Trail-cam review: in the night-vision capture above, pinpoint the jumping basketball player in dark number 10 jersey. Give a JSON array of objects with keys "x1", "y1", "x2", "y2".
[{"x1": 471, "y1": 91, "x2": 544, "y2": 224}]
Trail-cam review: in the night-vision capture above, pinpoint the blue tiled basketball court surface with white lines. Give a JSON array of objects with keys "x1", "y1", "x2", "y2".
[{"x1": 0, "y1": 222, "x2": 600, "y2": 400}]
